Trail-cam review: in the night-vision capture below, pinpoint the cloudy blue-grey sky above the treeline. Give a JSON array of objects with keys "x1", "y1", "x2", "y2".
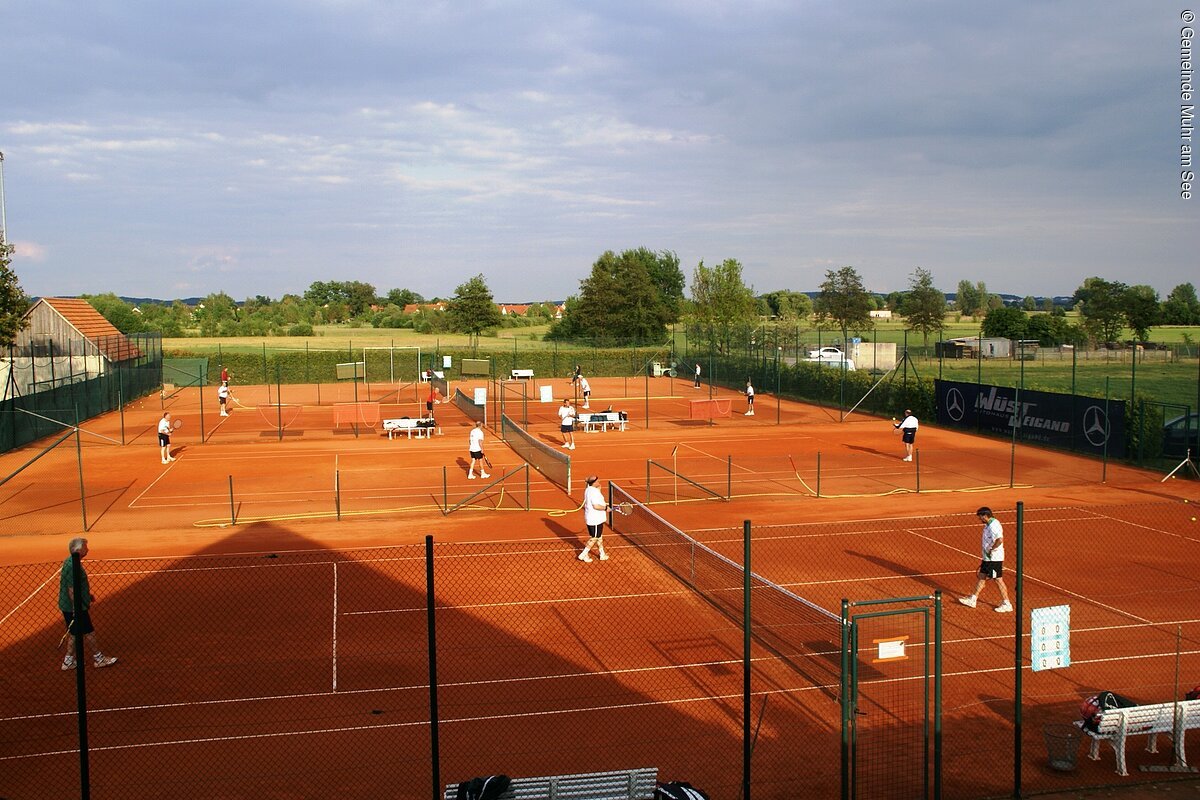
[{"x1": 0, "y1": 0, "x2": 1200, "y2": 302}]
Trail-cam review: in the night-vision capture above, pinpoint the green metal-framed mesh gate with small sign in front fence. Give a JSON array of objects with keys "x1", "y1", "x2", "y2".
[{"x1": 841, "y1": 594, "x2": 942, "y2": 800}]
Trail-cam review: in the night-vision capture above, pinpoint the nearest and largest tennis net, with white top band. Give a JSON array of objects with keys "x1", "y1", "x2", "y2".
[{"x1": 610, "y1": 483, "x2": 842, "y2": 696}]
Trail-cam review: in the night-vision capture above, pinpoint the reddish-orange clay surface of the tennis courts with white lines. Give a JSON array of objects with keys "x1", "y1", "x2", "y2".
[{"x1": 0, "y1": 379, "x2": 1200, "y2": 798}]
